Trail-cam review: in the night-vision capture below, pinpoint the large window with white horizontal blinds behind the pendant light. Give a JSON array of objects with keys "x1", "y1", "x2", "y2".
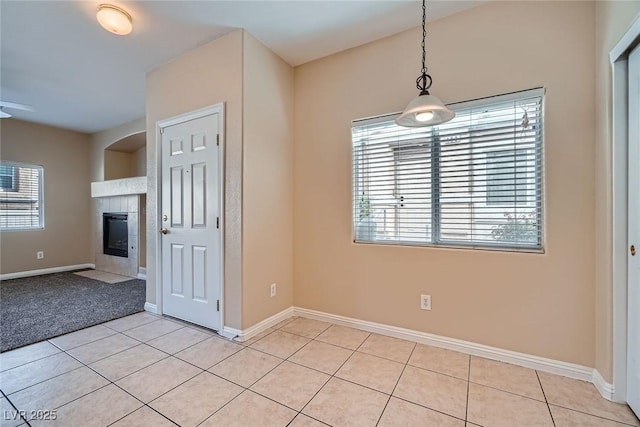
[{"x1": 351, "y1": 89, "x2": 544, "y2": 250}]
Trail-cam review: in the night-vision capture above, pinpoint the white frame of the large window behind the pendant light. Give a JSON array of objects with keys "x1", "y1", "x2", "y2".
[{"x1": 350, "y1": 87, "x2": 547, "y2": 254}]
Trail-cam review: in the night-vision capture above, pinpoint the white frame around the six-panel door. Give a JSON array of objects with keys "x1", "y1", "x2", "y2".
[{"x1": 154, "y1": 102, "x2": 225, "y2": 332}]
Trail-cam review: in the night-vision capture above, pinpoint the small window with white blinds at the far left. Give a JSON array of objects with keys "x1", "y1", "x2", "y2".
[{"x1": 0, "y1": 161, "x2": 44, "y2": 230}]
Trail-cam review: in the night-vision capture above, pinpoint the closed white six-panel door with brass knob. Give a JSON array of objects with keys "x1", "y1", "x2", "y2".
[{"x1": 160, "y1": 113, "x2": 222, "y2": 330}]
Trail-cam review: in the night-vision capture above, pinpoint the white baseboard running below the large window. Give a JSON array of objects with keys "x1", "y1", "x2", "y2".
[{"x1": 293, "y1": 307, "x2": 613, "y2": 394}]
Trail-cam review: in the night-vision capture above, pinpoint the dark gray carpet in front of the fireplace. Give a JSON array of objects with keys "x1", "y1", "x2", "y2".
[{"x1": 0, "y1": 272, "x2": 145, "y2": 352}]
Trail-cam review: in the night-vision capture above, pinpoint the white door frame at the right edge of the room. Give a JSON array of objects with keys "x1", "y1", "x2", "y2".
[{"x1": 609, "y1": 17, "x2": 640, "y2": 402}]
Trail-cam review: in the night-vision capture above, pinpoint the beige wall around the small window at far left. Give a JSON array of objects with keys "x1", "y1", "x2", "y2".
[{"x1": 0, "y1": 119, "x2": 93, "y2": 274}]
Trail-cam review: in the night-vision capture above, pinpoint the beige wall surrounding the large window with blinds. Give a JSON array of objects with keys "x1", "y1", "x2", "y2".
[{"x1": 294, "y1": 2, "x2": 595, "y2": 366}]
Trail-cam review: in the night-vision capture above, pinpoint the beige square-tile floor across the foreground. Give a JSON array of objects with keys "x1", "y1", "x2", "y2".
[{"x1": 0, "y1": 313, "x2": 640, "y2": 427}]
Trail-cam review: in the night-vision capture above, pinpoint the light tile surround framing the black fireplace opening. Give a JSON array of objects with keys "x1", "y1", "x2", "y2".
[{"x1": 94, "y1": 194, "x2": 143, "y2": 277}]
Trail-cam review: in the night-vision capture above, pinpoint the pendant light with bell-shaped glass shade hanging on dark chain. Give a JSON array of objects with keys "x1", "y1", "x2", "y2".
[{"x1": 396, "y1": 0, "x2": 456, "y2": 127}]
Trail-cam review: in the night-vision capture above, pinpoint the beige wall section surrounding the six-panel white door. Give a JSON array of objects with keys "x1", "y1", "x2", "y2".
[{"x1": 146, "y1": 30, "x2": 243, "y2": 328}]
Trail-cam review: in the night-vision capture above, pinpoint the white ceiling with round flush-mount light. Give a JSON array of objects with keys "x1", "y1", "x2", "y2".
[{"x1": 0, "y1": 0, "x2": 488, "y2": 133}]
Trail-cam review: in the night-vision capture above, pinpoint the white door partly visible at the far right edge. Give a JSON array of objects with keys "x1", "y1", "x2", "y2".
[{"x1": 627, "y1": 41, "x2": 640, "y2": 417}]
